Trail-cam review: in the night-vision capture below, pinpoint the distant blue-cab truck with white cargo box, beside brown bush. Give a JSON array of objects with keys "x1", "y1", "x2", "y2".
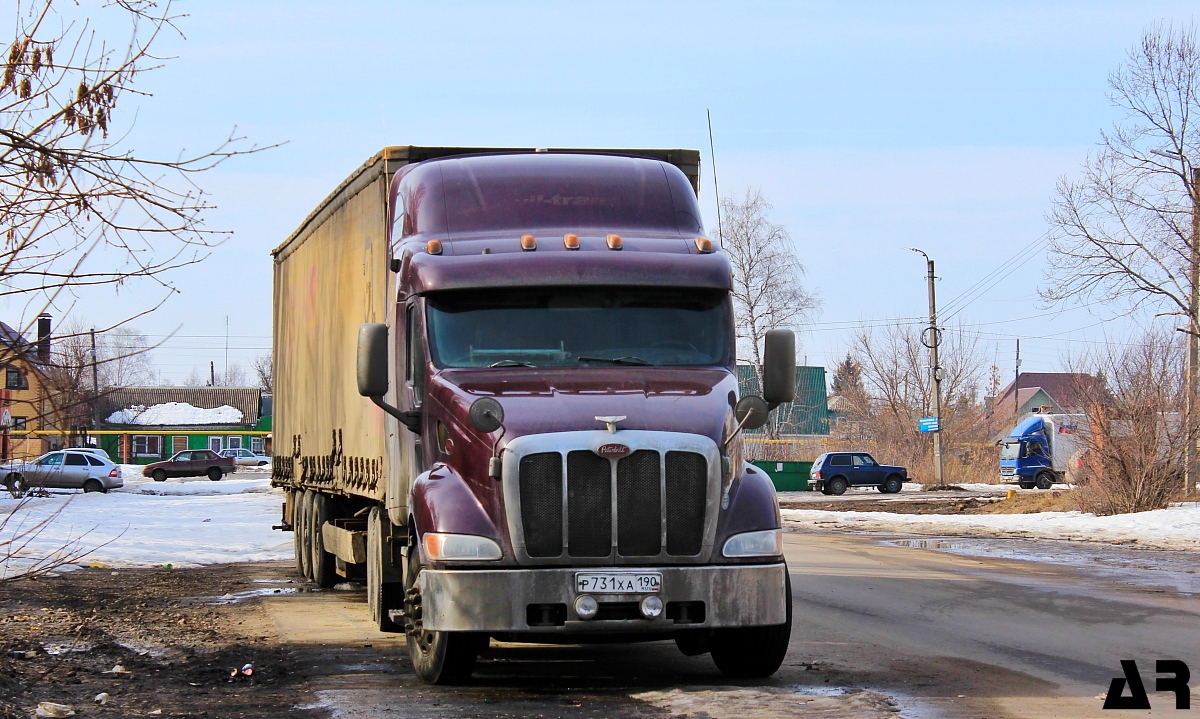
[{"x1": 1000, "y1": 414, "x2": 1087, "y2": 490}]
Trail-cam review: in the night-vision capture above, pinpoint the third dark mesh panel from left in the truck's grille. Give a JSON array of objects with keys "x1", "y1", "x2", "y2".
[{"x1": 617, "y1": 449, "x2": 667, "y2": 557}]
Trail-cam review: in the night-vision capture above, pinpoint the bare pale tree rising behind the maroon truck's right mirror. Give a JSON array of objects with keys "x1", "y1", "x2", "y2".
[{"x1": 721, "y1": 190, "x2": 821, "y2": 436}]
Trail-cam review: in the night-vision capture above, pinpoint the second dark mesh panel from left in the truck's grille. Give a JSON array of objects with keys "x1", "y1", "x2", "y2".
[{"x1": 566, "y1": 451, "x2": 612, "y2": 557}]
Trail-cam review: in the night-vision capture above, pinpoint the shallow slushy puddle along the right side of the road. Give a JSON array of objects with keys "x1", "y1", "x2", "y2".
[{"x1": 883, "y1": 537, "x2": 1200, "y2": 594}]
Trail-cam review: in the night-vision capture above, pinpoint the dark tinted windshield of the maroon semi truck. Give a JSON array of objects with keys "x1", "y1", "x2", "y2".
[{"x1": 426, "y1": 288, "x2": 732, "y2": 367}]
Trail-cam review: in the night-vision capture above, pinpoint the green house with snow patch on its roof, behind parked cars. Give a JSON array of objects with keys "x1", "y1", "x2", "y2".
[{"x1": 95, "y1": 387, "x2": 271, "y2": 465}]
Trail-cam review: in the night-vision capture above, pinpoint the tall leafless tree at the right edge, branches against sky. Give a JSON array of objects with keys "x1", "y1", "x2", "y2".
[{"x1": 1042, "y1": 25, "x2": 1200, "y2": 494}]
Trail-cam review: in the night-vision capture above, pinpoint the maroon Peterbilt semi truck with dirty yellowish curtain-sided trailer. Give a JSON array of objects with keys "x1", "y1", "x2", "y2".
[{"x1": 272, "y1": 146, "x2": 796, "y2": 683}]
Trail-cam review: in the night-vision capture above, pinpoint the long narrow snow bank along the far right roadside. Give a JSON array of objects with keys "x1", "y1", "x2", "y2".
[{"x1": 782, "y1": 505, "x2": 1200, "y2": 550}]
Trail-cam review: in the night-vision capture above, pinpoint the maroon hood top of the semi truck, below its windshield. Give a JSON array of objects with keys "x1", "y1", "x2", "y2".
[{"x1": 430, "y1": 367, "x2": 738, "y2": 444}]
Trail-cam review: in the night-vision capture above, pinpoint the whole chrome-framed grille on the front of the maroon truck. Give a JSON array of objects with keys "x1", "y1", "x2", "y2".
[{"x1": 503, "y1": 430, "x2": 722, "y2": 567}]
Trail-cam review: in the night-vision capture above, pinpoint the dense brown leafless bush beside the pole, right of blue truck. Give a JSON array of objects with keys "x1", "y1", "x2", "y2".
[{"x1": 1073, "y1": 329, "x2": 1196, "y2": 515}]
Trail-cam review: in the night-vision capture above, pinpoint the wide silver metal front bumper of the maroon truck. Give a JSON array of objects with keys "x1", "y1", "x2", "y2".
[{"x1": 419, "y1": 563, "x2": 787, "y2": 634}]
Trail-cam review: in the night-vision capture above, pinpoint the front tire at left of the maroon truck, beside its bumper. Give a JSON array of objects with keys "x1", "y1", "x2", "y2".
[{"x1": 404, "y1": 533, "x2": 488, "y2": 684}]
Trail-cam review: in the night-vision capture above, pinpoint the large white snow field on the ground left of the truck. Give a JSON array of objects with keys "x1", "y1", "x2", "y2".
[{"x1": 0, "y1": 474, "x2": 292, "y2": 577}]
